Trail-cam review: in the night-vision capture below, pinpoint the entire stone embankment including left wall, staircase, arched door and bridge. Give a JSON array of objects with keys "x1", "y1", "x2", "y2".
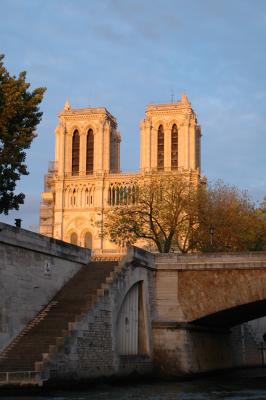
[{"x1": 0, "y1": 224, "x2": 266, "y2": 385}]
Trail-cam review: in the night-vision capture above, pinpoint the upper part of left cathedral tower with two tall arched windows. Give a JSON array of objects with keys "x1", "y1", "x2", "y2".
[{"x1": 55, "y1": 101, "x2": 120, "y2": 176}]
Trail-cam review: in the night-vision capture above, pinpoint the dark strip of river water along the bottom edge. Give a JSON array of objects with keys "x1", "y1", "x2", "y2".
[{"x1": 2, "y1": 373, "x2": 266, "y2": 400}]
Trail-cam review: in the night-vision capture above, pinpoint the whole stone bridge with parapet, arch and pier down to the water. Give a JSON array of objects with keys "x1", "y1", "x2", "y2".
[{"x1": 145, "y1": 251, "x2": 266, "y2": 375}]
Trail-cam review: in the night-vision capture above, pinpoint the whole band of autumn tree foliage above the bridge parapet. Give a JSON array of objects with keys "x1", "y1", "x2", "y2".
[{"x1": 103, "y1": 173, "x2": 266, "y2": 253}]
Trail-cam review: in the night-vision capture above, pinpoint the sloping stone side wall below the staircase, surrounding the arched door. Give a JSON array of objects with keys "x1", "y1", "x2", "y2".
[{"x1": 43, "y1": 250, "x2": 153, "y2": 381}]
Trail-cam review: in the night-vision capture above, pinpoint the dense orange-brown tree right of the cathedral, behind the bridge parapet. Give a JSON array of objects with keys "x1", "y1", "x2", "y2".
[{"x1": 193, "y1": 181, "x2": 265, "y2": 252}]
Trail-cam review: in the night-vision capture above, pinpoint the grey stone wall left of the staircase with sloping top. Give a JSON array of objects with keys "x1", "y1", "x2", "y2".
[{"x1": 0, "y1": 223, "x2": 90, "y2": 351}]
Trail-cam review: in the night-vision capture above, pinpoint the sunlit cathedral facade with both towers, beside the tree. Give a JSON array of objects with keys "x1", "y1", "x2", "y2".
[{"x1": 40, "y1": 95, "x2": 201, "y2": 254}]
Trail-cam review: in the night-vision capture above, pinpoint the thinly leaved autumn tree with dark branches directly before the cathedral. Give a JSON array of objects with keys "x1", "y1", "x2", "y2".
[{"x1": 103, "y1": 173, "x2": 200, "y2": 253}]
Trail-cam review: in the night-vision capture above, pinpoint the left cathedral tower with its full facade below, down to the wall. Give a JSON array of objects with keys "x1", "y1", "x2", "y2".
[{"x1": 40, "y1": 101, "x2": 121, "y2": 247}]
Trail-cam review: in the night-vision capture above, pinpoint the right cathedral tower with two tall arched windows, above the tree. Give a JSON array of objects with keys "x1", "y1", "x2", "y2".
[{"x1": 140, "y1": 95, "x2": 201, "y2": 173}]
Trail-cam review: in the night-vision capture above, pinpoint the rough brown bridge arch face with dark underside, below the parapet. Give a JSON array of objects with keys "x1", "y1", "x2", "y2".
[{"x1": 178, "y1": 262, "x2": 266, "y2": 327}]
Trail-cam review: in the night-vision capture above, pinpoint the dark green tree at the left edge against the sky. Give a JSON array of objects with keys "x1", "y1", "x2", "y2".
[{"x1": 0, "y1": 55, "x2": 46, "y2": 214}]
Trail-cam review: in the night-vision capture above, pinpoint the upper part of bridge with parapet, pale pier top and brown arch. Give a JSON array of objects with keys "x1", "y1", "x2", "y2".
[{"x1": 152, "y1": 252, "x2": 266, "y2": 328}]
